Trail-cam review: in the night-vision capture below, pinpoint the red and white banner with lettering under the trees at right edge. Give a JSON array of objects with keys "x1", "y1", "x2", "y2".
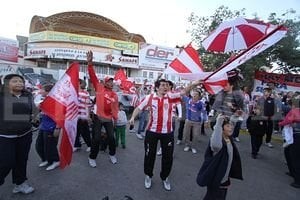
[{"x1": 252, "y1": 71, "x2": 300, "y2": 95}]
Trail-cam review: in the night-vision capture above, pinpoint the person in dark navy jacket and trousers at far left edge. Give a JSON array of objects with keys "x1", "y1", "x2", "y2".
[{"x1": 0, "y1": 74, "x2": 36, "y2": 194}]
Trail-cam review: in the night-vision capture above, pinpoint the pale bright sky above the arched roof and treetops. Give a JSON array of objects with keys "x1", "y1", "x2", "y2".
[{"x1": 0, "y1": 0, "x2": 300, "y2": 47}]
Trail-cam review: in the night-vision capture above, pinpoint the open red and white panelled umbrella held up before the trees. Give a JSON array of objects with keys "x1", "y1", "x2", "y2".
[{"x1": 202, "y1": 17, "x2": 274, "y2": 53}]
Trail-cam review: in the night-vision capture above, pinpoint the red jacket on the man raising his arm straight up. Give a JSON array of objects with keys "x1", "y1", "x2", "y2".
[{"x1": 88, "y1": 65, "x2": 119, "y2": 120}]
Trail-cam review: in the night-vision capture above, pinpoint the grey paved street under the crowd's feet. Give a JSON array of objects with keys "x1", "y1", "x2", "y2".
[{"x1": 0, "y1": 122, "x2": 300, "y2": 200}]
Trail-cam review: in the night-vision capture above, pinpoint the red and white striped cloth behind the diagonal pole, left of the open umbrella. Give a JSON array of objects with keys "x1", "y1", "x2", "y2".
[{"x1": 165, "y1": 43, "x2": 228, "y2": 94}]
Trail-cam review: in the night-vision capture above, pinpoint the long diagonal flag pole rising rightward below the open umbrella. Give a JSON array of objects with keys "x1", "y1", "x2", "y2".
[{"x1": 203, "y1": 25, "x2": 286, "y2": 81}]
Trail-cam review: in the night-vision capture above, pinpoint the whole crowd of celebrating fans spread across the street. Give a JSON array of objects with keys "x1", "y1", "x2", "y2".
[{"x1": 0, "y1": 51, "x2": 300, "y2": 199}]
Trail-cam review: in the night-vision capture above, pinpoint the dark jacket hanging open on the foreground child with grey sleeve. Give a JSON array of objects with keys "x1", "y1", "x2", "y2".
[{"x1": 197, "y1": 139, "x2": 243, "y2": 187}]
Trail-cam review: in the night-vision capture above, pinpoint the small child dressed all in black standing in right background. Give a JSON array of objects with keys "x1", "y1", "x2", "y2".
[{"x1": 246, "y1": 106, "x2": 266, "y2": 159}]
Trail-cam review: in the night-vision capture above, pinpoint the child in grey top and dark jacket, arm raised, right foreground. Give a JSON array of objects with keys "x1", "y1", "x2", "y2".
[{"x1": 197, "y1": 114, "x2": 243, "y2": 200}]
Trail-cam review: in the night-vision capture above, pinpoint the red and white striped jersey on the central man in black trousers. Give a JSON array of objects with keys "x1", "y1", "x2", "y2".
[{"x1": 138, "y1": 93, "x2": 180, "y2": 134}]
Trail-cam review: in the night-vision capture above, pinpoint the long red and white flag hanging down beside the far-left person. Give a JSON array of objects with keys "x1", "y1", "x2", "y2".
[{"x1": 40, "y1": 63, "x2": 79, "y2": 168}]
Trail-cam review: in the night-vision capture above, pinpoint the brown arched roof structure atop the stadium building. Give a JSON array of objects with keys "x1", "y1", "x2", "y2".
[{"x1": 29, "y1": 11, "x2": 146, "y2": 43}]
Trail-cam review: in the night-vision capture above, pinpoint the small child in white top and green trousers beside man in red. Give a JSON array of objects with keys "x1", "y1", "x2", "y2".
[{"x1": 115, "y1": 103, "x2": 127, "y2": 149}]
